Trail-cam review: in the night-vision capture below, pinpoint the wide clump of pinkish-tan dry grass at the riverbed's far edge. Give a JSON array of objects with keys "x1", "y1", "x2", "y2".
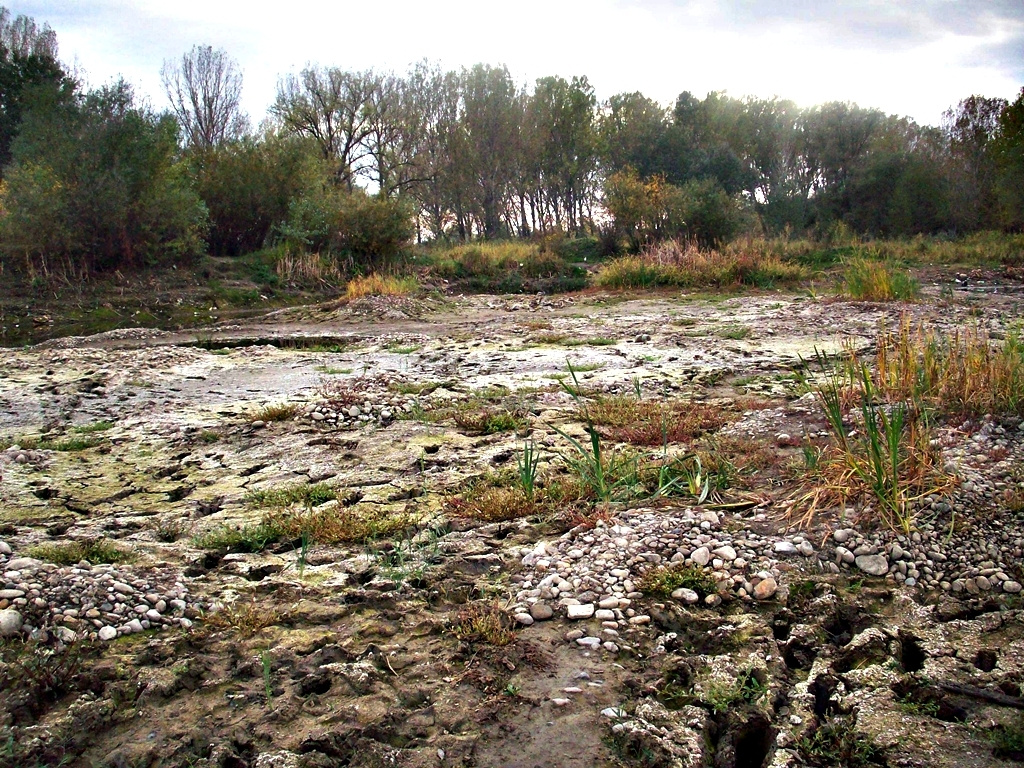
[{"x1": 596, "y1": 240, "x2": 807, "y2": 290}]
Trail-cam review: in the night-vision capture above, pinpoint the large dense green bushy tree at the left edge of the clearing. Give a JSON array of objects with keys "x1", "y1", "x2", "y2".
[{"x1": 0, "y1": 82, "x2": 207, "y2": 271}]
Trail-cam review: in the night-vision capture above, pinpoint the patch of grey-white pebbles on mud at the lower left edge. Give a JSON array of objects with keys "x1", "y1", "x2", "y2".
[{"x1": 0, "y1": 542, "x2": 203, "y2": 643}]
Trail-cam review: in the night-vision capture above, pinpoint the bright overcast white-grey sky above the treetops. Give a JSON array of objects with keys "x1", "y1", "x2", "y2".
[{"x1": 8, "y1": 0, "x2": 1024, "y2": 125}]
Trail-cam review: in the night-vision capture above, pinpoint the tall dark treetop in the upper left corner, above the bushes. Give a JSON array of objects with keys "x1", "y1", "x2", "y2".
[{"x1": 0, "y1": 6, "x2": 68, "y2": 178}]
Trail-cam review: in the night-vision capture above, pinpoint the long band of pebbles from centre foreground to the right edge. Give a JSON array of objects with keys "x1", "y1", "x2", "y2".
[{"x1": 513, "y1": 421, "x2": 1024, "y2": 638}]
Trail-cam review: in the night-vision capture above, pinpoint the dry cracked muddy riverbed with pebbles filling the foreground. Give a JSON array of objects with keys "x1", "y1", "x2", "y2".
[{"x1": 0, "y1": 272, "x2": 1024, "y2": 768}]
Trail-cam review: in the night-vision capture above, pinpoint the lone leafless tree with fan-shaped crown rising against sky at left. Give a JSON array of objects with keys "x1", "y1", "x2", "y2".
[{"x1": 160, "y1": 45, "x2": 249, "y2": 150}]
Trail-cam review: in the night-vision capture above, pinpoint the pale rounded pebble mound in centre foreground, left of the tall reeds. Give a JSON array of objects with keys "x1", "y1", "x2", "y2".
[{"x1": 514, "y1": 508, "x2": 817, "y2": 650}]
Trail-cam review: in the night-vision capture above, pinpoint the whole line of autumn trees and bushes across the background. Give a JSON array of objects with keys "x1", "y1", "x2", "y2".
[{"x1": 0, "y1": 8, "x2": 1024, "y2": 270}]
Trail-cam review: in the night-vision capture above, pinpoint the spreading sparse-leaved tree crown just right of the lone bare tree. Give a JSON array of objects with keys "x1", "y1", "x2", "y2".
[{"x1": 270, "y1": 67, "x2": 381, "y2": 190}]
